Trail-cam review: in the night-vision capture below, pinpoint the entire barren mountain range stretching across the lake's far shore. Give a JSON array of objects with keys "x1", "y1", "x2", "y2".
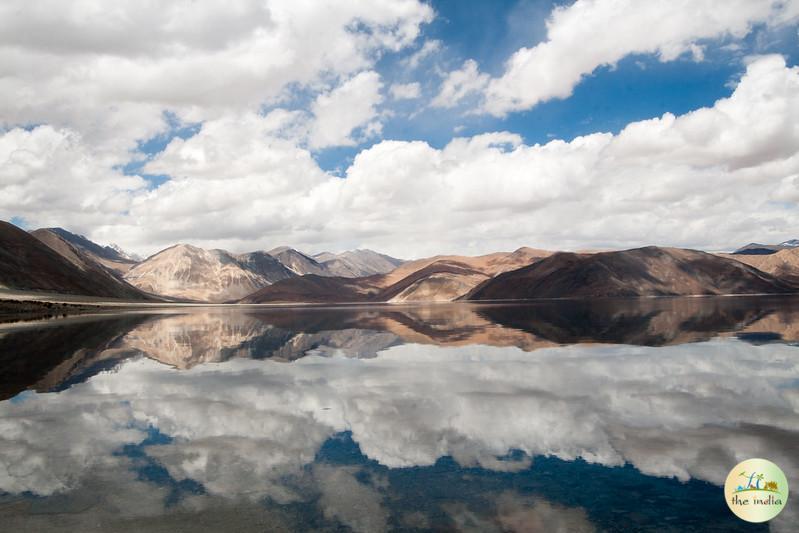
[{"x1": 0, "y1": 222, "x2": 799, "y2": 304}]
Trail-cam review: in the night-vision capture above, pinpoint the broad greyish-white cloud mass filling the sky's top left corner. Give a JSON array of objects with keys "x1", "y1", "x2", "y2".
[{"x1": 0, "y1": 0, "x2": 433, "y2": 156}]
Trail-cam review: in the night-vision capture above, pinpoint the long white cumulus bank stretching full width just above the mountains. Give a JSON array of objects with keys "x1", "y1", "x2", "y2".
[{"x1": 0, "y1": 56, "x2": 799, "y2": 257}]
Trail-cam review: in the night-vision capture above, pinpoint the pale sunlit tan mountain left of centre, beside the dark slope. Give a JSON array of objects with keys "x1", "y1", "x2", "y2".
[{"x1": 125, "y1": 244, "x2": 287, "y2": 302}]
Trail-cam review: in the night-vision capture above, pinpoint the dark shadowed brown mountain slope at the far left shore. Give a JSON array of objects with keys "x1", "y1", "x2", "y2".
[{"x1": 0, "y1": 221, "x2": 151, "y2": 300}]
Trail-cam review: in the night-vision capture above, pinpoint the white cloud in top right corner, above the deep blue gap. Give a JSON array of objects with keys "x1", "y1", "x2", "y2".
[{"x1": 484, "y1": 0, "x2": 799, "y2": 115}]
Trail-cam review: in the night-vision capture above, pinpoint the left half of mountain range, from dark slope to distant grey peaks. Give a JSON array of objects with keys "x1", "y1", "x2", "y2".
[{"x1": 0, "y1": 222, "x2": 404, "y2": 303}]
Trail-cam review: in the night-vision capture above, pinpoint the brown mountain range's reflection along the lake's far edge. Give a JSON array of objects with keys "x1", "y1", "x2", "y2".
[{"x1": 0, "y1": 298, "x2": 799, "y2": 398}]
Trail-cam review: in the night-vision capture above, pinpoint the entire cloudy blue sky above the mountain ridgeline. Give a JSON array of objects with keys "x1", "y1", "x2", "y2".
[{"x1": 0, "y1": 0, "x2": 799, "y2": 258}]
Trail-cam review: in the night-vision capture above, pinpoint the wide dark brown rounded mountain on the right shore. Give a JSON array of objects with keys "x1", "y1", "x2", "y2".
[{"x1": 465, "y1": 246, "x2": 799, "y2": 300}]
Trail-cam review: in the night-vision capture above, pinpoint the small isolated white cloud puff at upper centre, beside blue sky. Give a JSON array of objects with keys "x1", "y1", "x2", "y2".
[{"x1": 308, "y1": 71, "x2": 383, "y2": 149}]
